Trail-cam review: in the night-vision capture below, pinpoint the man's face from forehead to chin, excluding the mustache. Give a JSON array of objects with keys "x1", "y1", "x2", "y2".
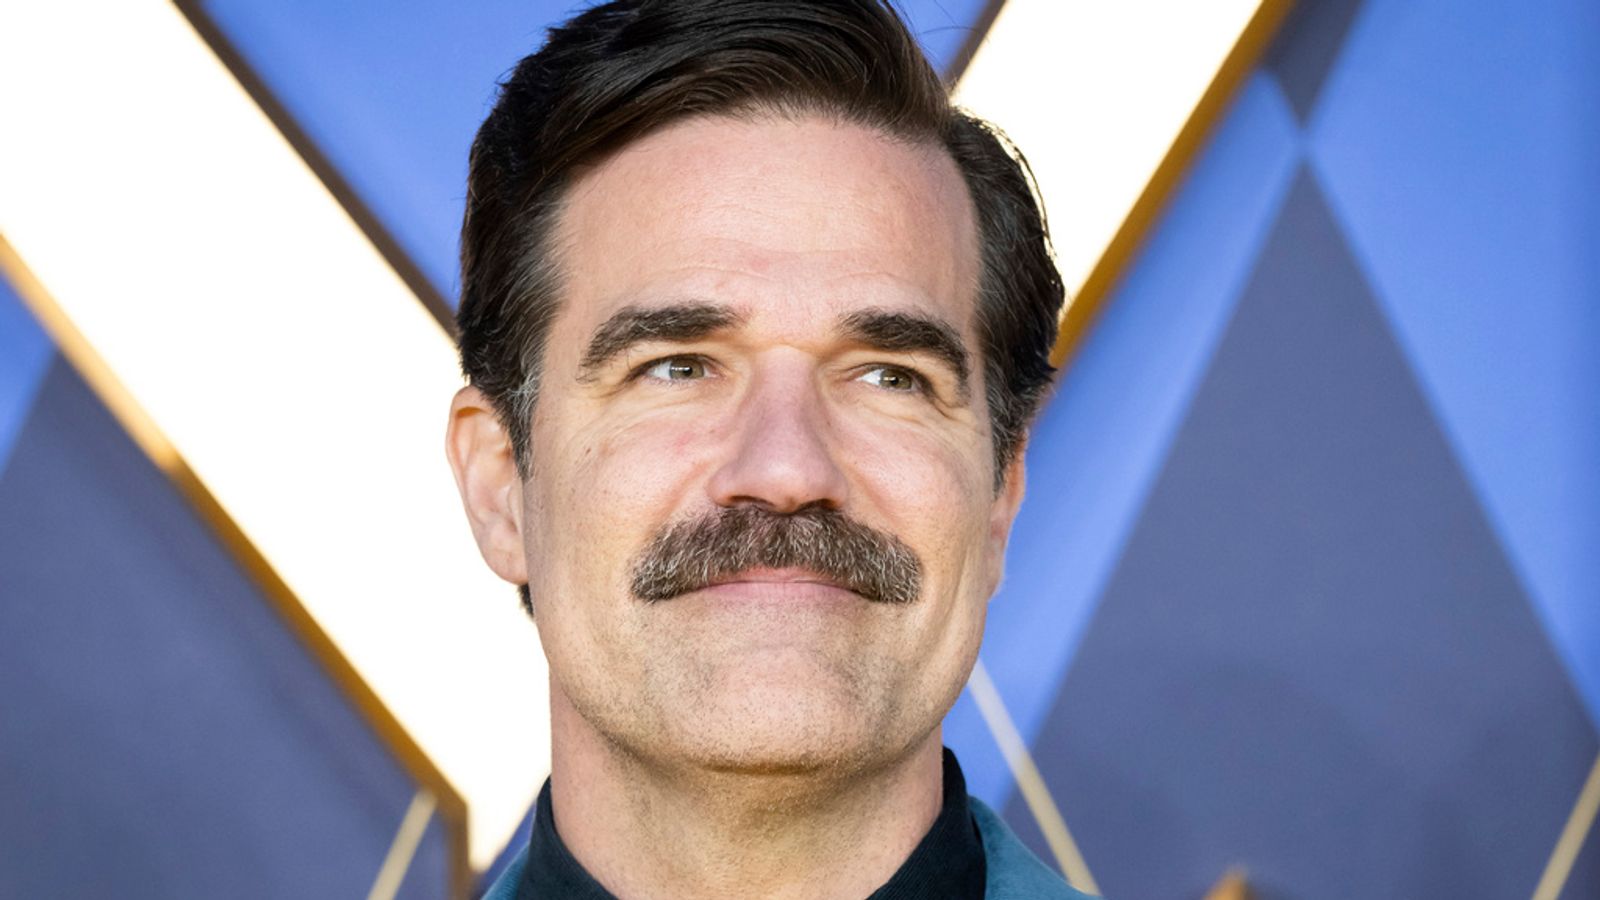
[{"x1": 464, "y1": 117, "x2": 1021, "y2": 770}]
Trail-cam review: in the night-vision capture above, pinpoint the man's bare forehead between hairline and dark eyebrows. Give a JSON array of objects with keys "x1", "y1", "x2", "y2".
[{"x1": 558, "y1": 115, "x2": 978, "y2": 331}]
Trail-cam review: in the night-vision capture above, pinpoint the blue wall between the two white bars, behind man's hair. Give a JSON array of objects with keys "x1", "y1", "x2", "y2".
[{"x1": 190, "y1": 0, "x2": 989, "y2": 307}]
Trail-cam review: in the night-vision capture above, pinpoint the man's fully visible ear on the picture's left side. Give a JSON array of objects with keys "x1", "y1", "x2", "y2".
[{"x1": 445, "y1": 386, "x2": 528, "y2": 585}]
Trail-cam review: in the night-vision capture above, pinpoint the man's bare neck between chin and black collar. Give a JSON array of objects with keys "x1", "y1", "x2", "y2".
[{"x1": 550, "y1": 685, "x2": 942, "y2": 900}]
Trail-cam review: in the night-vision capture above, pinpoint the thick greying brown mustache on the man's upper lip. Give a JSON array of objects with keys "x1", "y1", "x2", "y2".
[{"x1": 632, "y1": 506, "x2": 922, "y2": 604}]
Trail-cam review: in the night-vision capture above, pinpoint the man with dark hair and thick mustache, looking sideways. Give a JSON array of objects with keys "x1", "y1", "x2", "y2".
[{"x1": 448, "y1": 0, "x2": 1075, "y2": 900}]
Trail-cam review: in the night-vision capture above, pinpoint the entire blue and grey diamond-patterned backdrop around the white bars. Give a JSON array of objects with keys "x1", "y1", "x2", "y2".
[{"x1": 0, "y1": 0, "x2": 1600, "y2": 898}]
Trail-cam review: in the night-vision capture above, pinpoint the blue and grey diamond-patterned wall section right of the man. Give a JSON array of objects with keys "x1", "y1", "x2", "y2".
[{"x1": 949, "y1": 0, "x2": 1600, "y2": 898}]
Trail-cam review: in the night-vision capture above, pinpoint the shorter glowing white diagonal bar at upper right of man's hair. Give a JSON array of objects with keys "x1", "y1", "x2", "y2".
[{"x1": 955, "y1": 0, "x2": 1261, "y2": 296}]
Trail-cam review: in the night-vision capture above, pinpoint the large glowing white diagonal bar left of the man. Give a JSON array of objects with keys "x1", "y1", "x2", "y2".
[{"x1": 0, "y1": 0, "x2": 549, "y2": 868}]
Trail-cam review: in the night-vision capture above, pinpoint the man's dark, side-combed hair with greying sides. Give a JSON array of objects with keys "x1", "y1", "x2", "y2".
[{"x1": 456, "y1": 0, "x2": 1064, "y2": 485}]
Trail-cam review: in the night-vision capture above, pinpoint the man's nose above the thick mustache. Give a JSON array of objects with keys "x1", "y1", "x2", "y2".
[{"x1": 709, "y1": 360, "x2": 848, "y2": 512}]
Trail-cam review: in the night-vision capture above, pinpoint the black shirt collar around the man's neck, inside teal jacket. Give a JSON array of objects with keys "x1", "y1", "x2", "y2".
[{"x1": 517, "y1": 748, "x2": 986, "y2": 900}]
